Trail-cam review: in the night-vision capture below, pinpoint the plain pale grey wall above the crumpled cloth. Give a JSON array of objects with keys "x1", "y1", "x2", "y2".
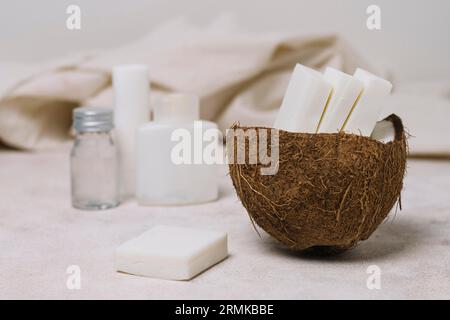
[{"x1": 0, "y1": 0, "x2": 450, "y2": 80}]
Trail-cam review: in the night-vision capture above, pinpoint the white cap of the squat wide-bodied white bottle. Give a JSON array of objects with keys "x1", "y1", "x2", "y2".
[{"x1": 153, "y1": 93, "x2": 200, "y2": 123}]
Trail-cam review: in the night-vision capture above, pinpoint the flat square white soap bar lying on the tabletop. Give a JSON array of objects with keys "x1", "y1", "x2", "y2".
[{"x1": 116, "y1": 226, "x2": 228, "y2": 280}]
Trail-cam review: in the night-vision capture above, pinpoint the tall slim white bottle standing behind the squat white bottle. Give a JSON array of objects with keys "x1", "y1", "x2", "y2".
[{"x1": 113, "y1": 65, "x2": 150, "y2": 198}]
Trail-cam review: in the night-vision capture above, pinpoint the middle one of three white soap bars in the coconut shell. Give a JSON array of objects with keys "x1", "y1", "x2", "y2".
[{"x1": 318, "y1": 68, "x2": 363, "y2": 133}]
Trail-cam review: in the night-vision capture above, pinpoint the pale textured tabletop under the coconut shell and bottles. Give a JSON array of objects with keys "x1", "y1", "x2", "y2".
[{"x1": 0, "y1": 151, "x2": 450, "y2": 299}]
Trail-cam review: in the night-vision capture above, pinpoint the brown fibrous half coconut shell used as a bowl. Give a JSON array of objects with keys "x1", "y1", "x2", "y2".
[{"x1": 229, "y1": 114, "x2": 407, "y2": 251}]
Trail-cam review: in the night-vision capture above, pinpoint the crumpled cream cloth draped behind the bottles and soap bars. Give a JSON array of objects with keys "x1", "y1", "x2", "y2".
[{"x1": 0, "y1": 18, "x2": 369, "y2": 149}]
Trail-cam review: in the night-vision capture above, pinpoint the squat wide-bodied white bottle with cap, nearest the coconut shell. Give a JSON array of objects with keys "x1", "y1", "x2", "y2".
[{"x1": 137, "y1": 94, "x2": 221, "y2": 205}]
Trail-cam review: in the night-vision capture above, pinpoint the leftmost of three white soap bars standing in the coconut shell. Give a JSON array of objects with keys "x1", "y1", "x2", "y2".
[{"x1": 274, "y1": 64, "x2": 331, "y2": 133}]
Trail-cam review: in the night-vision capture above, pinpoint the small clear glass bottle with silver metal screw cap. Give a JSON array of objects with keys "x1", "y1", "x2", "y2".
[{"x1": 71, "y1": 107, "x2": 119, "y2": 210}]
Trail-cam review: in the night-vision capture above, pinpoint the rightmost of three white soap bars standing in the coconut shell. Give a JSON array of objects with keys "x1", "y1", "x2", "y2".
[{"x1": 342, "y1": 68, "x2": 392, "y2": 137}]
